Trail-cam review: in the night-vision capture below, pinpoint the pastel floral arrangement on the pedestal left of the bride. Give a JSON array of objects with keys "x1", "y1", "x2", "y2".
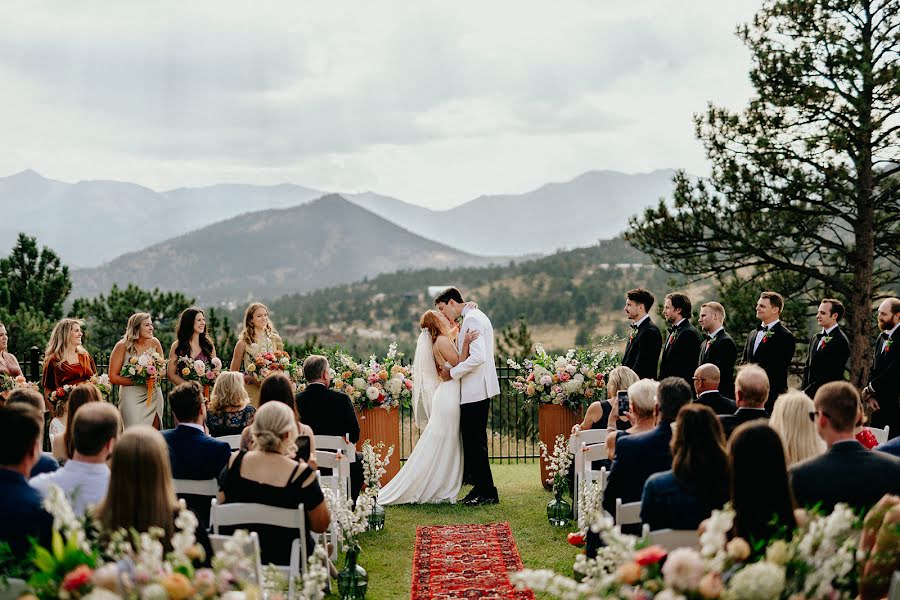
[{"x1": 332, "y1": 342, "x2": 413, "y2": 410}]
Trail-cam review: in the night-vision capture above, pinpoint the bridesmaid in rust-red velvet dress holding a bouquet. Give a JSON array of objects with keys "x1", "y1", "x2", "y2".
[{"x1": 41, "y1": 319, "x2": 97, "y2": 414}]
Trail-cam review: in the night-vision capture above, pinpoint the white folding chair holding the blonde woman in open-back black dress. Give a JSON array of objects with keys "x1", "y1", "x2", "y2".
[{"x1": 209, "y1": 498, "x2": 308, "y2": 598}]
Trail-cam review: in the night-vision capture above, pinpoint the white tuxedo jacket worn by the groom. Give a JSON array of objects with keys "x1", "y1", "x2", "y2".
[{"x1": 450, "y1": 308, "x2": 500, "y2": 404}]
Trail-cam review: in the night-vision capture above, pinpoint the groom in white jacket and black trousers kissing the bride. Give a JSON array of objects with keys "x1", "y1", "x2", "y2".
[{"x1": 434, "y1": 287, "x2": 500, "y2": 506}]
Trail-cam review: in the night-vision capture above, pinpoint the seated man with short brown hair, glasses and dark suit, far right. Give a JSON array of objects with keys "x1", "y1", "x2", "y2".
[{"x1": 791, "y1": 381, "x2": 900, "y2": 513}]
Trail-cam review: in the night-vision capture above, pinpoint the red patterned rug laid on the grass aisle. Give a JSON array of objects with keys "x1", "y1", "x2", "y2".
[{"x1": 412, "y1": 523, "x2": 534, "y2": 600}]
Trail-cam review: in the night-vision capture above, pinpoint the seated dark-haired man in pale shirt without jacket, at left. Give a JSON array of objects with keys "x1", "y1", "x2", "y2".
[{"x1": 28, "y1": 402, "x2": 122, "y2": 516}]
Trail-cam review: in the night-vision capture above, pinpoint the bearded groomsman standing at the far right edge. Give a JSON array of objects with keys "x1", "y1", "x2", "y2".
[{"x1": 863, "y1": 298, "x2": 900, "y2": 438}]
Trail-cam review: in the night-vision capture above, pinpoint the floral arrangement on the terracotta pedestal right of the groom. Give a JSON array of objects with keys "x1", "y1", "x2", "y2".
[{"x1": 507, "y1": 337, "x2": 621, "y2": 409}]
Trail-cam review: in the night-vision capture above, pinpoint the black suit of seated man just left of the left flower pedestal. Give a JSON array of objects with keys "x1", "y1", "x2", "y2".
[{"x1": 297, "y1": 383, "x2": 363, "y2": 501}]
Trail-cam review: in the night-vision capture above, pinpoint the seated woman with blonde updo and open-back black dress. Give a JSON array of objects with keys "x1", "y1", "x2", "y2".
[{"x1": 219, "y1": 402, "x2": 331, "y2": 565}]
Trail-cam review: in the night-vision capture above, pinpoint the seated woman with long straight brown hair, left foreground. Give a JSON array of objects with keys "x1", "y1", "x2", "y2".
[{"x1": 94, "y1": 426, "x2": 213, "y2": 565}]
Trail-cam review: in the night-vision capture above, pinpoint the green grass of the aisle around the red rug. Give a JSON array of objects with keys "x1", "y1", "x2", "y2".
[{"x1": 334, "y1": 463, "x2": 579, "y2": 600}]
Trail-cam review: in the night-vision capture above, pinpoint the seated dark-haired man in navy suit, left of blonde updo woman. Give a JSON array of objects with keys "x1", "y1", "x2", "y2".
[{"x1": 163, "y1": 381, "x2": 231, "y2": 527}]
